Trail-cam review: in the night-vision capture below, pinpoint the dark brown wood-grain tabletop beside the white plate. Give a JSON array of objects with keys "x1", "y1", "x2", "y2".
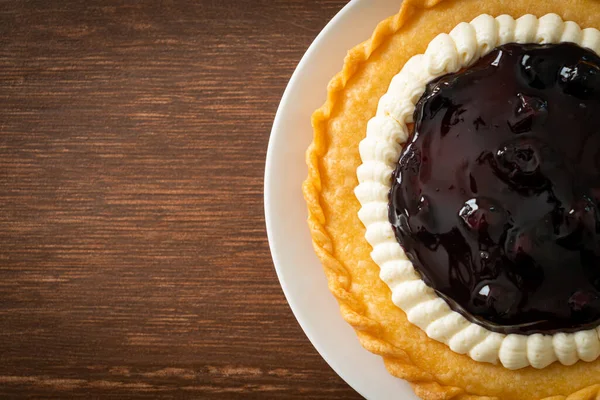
[{"x1": 0, "y1": 0, "x2": 358, "y2": 399}]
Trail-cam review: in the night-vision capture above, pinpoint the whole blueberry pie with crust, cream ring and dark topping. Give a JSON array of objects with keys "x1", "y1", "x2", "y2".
[{"x1": 303, "y1": 0, "x2": 600, "y2": 400}]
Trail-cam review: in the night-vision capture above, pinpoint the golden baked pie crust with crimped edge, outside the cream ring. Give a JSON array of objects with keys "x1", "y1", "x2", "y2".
[{"x1": 303, "y1": 0, "x2": 600, "y2": 400}]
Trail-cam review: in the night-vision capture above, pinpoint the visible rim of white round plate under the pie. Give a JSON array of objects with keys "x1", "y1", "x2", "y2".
[{"x1": 265, "y1": 0, "x2": 417, "y2": 400}]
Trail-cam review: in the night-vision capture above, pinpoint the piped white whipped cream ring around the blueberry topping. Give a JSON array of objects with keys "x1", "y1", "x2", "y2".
[{"x1": 354, "y1": 14, "x2": 600, "y2": 370}]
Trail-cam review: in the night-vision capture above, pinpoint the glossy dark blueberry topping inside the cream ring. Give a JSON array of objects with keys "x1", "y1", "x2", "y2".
[{"x1": 389, "y1": 43, "x2": 600, "y2": 334}]
